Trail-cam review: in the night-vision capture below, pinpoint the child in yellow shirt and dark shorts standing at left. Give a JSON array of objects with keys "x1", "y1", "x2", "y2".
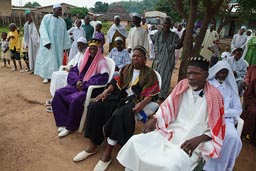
[{"x1": 7, "y1": 23, "x2": 23, "y2": 72}]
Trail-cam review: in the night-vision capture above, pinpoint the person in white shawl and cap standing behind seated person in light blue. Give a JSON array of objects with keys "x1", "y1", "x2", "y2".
[{"x1": 107, "y1": 15, "x2": 127, "y2": 52}]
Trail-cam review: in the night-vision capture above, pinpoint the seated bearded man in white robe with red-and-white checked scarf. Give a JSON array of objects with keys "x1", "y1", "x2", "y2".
[{"x1": 117, "y1": 57, "x2": 225, "y2": 171}]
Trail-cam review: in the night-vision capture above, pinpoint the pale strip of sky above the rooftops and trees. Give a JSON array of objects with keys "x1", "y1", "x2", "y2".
[{"x1": 12, "y1": 0, "x2": 130, "y2": 8}]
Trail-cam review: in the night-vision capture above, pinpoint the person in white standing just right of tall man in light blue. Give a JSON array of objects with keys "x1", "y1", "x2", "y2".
[{"x1": 68, "y1": 19, "x2": 85, "y2": 61}]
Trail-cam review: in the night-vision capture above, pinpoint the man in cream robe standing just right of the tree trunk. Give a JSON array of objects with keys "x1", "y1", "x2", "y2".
[{"x1": 200, "y1": 25, "x2": 219, "y2": 61}]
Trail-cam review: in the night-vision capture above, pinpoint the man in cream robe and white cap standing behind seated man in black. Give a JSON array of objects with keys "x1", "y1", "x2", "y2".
[{"x1": 127, "y1": 13, "x2": 148, "y2": 52}]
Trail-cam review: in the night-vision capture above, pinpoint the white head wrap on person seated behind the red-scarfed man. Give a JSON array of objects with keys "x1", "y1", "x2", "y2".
[{"x1": 208, "y1": 61, "x2": 238, "y2": 95}]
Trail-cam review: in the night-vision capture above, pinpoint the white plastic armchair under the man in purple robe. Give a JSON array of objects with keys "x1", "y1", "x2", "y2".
[{"x1": 78, "y1": 58, "x2": 115, "y2": 132}]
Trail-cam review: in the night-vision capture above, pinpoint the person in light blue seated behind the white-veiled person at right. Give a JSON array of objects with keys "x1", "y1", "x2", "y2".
[{"x1": 227, "y1": 48, "x2": 248, "y2": 97}]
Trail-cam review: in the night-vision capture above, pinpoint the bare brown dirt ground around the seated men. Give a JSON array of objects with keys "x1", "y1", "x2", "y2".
[{"x1": 0, "y1": 59, "x2": 256, "y2": 171}]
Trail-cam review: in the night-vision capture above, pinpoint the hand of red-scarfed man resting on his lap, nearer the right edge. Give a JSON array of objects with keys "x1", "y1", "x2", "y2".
[{"x1": 180, "y1": 134, "x2": 211, "y2": 157}]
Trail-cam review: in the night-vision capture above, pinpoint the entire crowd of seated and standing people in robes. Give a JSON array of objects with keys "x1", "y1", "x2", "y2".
[{"x1": 1, "y1": 4, "x2": 256, "y2": 171}]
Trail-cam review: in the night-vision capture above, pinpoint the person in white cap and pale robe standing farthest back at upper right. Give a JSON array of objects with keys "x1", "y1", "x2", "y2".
[{"x1": 231, "y1": 26, "x2": 247, "y2": 52}]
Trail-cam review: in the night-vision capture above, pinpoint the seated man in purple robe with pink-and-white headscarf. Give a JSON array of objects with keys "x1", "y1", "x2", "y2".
[{"x1": 52, "y1": 39, "x2": 109, "y2": 137}]
